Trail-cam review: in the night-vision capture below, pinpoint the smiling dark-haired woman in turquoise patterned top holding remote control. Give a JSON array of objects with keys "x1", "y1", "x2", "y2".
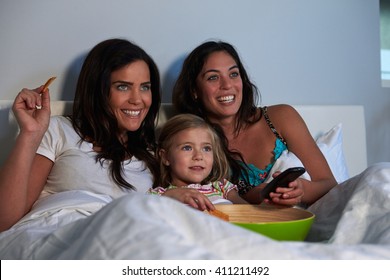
[{"x1": 172, "y1": 41, "x2": 336, "y2": 205}]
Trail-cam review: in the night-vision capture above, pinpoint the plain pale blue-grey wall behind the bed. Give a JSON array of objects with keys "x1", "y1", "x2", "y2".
[{"x1": 0, "y1": 0, "x2": 390, "y2": 164}]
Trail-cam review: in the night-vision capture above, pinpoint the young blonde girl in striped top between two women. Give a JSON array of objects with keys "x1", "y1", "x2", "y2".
[{"x1": 149, "y1": 114, "x2": 247, "y2": 205}]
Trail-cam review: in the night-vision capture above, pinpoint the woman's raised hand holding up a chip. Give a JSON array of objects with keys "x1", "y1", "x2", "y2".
[{"x1": 12, "y1": 86, "x2": 50, "y2": 134}]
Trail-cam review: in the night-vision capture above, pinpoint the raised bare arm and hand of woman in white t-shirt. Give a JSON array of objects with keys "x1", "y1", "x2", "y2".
[{"x1": 0, "y1": 87, "x2": 53, "y2": 231}]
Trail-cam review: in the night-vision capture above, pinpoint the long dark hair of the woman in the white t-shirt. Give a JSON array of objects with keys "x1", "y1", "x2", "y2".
[{"x1": 72, "y1": 39, "x2": 161, "y2": 189}]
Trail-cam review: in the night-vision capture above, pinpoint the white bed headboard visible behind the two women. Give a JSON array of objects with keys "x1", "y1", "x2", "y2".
[{"x1": 0, "y1": 100, "x2": 367, "y2": 176}]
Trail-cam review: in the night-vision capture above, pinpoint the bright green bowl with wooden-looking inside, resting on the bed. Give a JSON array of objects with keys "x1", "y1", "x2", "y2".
[{"x1": 215, "y1": 204, "x2": 315, "y2": 241}]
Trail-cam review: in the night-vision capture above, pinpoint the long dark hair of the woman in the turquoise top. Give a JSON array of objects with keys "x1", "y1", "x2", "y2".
[{"x1": 172, "y1": 41, "x2": 262, "y2": 182}]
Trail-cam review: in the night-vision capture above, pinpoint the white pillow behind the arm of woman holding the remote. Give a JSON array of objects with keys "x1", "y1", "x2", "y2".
[{"x1": 266, "y1": 123, "x2": 349, "y2": 183}]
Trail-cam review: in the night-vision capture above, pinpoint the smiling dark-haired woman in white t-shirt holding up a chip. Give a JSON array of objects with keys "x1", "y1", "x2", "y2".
[{"x1": 0, "y1": 39, "x2": 161, "y2": 230}]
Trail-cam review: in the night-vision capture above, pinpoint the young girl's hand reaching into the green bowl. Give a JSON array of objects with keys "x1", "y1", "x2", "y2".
[{"x1": 163, "y1": 188, "x2": 215, "y2": 211}]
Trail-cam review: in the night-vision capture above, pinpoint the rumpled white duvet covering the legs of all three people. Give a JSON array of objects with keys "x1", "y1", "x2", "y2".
[{"x1": 0, "y1": 163, "x2": 390, "y2": 260}]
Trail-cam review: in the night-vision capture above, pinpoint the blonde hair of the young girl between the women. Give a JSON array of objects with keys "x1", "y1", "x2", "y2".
[{"x1": 157, "y1": 114, "x2": 230, "y2": 188}]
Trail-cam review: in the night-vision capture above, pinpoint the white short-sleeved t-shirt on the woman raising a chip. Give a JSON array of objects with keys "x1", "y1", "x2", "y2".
[{"x1": 37, "y1": 116, "x2": 153, "y2": 198}]
